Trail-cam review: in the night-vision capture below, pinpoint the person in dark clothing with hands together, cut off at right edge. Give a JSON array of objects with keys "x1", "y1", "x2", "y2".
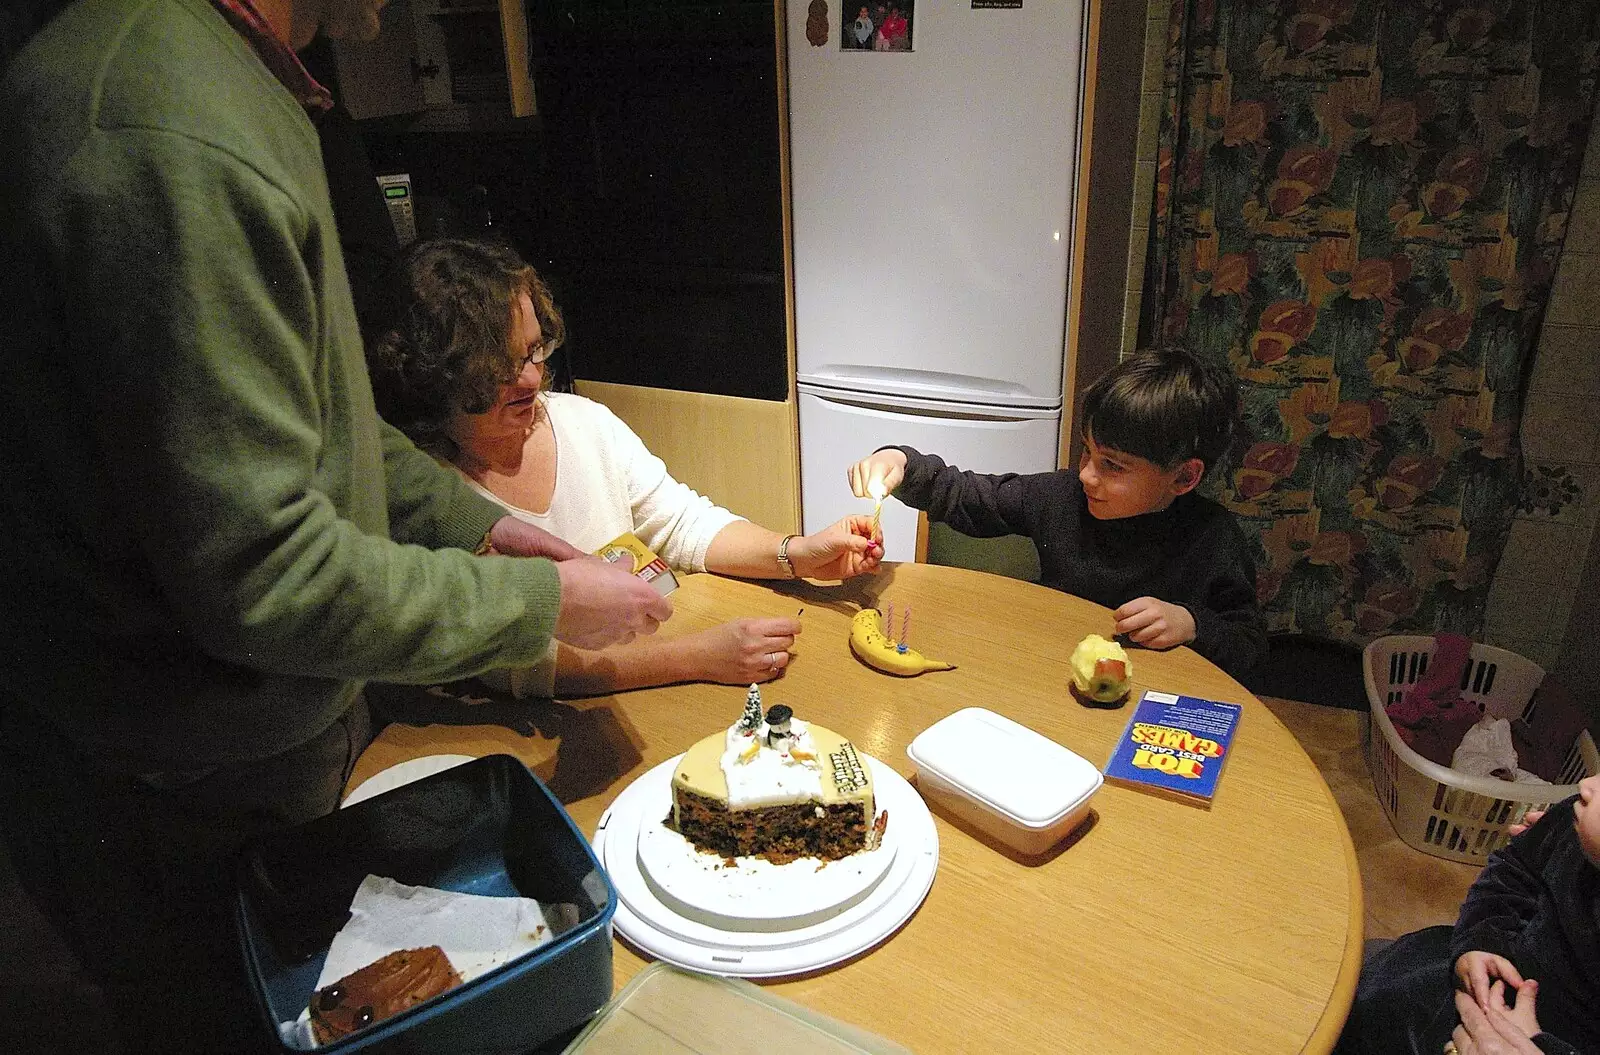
[{"x1": 1334, "y1": 776, "x2": 1600, "y2": 1055}]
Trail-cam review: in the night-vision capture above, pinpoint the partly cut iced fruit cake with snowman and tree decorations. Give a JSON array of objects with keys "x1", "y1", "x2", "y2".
[{"x1": 667, "y1": 685, "x2": 888, "y2": 864}]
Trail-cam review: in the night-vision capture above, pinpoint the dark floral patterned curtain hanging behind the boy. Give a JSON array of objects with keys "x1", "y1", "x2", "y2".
[{"x1": 1141, "y1": 0, "x2": 1600, "y2": 645}]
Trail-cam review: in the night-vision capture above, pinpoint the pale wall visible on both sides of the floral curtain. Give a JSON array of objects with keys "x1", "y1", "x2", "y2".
[{"x1": 1122, "y1": 0, "x2": 1600, "y2": 685}]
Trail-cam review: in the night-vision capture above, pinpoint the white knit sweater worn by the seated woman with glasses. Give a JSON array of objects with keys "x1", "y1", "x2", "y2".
[{"x1": 467, "y1": 392, "x2": 742, "y2": 696}]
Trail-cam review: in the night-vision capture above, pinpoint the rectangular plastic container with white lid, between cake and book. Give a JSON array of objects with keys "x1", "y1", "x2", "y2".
[{"x1": 906, "y1": 708, "x2": 1104, "y2": 856}]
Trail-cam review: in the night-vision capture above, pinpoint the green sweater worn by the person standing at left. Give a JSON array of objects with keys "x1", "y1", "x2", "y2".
[{"x1": 0, "y1": 0, "x2": 560, "y2": 770}]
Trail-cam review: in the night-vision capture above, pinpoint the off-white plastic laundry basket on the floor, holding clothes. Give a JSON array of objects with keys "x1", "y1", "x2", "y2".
[{"x1": 1362, "y1": 636, "x2": 1600, "y2": 864}]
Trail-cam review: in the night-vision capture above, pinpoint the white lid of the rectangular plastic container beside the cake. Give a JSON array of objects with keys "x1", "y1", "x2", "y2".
[{"x1": 906, "y1": 708, "x2": 1104, "y2": 828}]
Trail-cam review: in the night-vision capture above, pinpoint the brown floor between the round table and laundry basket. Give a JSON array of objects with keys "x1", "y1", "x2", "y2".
[{"x1": 1261, "y1": 696, "x2": 1478, "y2": 938}]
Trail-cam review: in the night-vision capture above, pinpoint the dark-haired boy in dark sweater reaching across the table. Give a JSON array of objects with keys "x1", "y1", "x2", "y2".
[{"x1": 850, "y1": 349, "x2": 1267, "y2": 677}]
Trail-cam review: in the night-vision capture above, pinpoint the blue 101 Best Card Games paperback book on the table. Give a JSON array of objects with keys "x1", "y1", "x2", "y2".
[{"x1": 1106, "y1": 690, "x2": 1243, "y2": 808}]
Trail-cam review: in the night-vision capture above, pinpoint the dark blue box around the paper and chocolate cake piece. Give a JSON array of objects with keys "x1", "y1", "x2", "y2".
[{"x1": 235, "y1": 754, "x2": 616, "y2": 1055}]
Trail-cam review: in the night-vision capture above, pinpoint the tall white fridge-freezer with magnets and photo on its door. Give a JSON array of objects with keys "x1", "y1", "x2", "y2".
[{"x1": 786, "y1": 0, "x2": 1085, "y2": 560}]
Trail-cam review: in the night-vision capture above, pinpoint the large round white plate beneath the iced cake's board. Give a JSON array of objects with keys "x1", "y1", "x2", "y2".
[{"x1": 594, "y1": 756, "x2": 939, "y2": 978}]
